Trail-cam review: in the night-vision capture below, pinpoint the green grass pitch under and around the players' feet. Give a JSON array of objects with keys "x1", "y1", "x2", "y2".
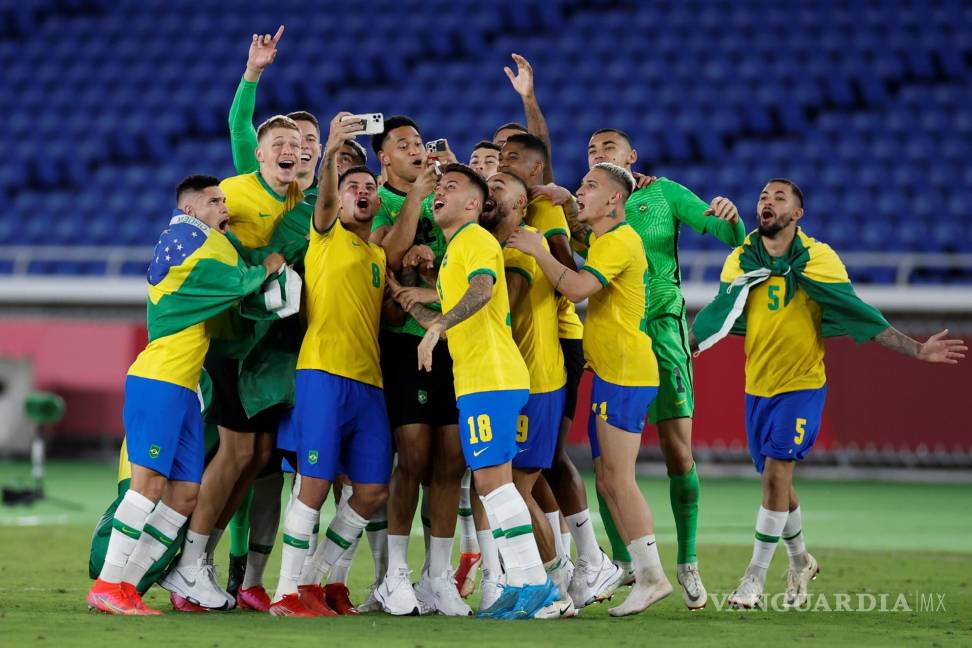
[{"x1": 0, "y1": 462, "x2": 972, "y2": 648}]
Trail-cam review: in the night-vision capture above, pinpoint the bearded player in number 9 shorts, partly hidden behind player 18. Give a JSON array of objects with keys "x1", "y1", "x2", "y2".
[{"x1": 479, "y1": 173, "x2": 580, "y2": 617}]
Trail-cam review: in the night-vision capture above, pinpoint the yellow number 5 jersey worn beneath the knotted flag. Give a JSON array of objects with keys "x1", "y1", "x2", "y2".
[{"x1": 720, "y1": 243, "x2": 828, "y2": 396}]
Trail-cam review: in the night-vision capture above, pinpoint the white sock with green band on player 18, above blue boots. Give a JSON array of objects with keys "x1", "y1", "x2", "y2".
[{"x1": 480, "y1": 484, "x2": 547, "y2": 587}]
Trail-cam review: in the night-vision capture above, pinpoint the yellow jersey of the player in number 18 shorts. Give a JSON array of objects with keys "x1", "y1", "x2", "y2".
[{"x1": 436, "y1": 222, "x2": 530, "y2": 396}]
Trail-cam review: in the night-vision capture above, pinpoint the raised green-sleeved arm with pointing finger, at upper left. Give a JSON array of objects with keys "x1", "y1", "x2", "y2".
[{"x1": 229, "y1": 25, "x2": 284, "y2": 173}]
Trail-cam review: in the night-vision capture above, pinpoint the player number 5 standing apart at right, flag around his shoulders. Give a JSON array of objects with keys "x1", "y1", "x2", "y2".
[{"x1": 691, "y1": 178, "x2": 968, "y2": 608}]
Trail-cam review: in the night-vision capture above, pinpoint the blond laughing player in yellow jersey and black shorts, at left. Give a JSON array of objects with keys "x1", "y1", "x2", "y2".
[{"x1": 162, "y1": 115, "x2": 301, "y2": 607}]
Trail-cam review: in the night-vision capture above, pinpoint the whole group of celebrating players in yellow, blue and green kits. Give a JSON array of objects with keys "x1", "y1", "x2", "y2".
[{"x1": 87, "y1": 27, "x2": 966, "y2": 619}]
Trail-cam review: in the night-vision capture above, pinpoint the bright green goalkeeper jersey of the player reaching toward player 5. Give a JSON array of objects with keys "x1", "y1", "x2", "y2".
[{"x1": 624, "y1": 178, "x2": 746, "y2": 319}]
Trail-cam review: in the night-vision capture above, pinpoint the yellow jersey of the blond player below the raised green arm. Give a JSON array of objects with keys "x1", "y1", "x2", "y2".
[{"x1": 219, "y1": 171, "x2": 304, "y2": 248}]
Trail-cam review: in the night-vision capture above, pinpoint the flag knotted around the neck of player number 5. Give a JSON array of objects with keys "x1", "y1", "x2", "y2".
[{"x1": 692, "y1": 228, "x2": 891, "y2": 351}]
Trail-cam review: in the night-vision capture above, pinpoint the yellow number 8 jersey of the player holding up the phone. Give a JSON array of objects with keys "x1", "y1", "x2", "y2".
[{"x1": 297, "y1": 219, "x2": 385, "y2": 387}]
